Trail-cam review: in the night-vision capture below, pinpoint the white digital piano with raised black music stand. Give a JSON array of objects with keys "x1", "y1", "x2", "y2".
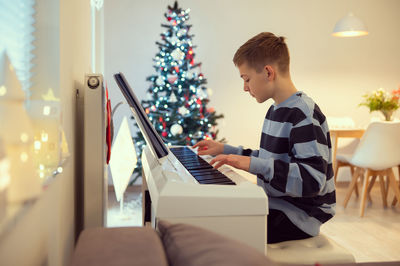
[{"x1": 114, "y1": 73, "x2": 268, "y2": 253}]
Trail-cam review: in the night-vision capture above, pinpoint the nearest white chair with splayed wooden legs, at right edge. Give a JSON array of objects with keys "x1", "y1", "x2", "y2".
[{"x1": 344, "y1": 122, "x2": 400, "y2": 216}]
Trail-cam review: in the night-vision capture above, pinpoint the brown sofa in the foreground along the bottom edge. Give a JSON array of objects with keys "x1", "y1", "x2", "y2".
[{"x1": 71, "y1": 221, "x2": 400, "y2": 266}]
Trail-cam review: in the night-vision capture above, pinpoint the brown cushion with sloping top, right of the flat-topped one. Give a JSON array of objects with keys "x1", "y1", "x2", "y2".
[{"x1": 157, "y1": 221, "x2": 276, "y2": 266}]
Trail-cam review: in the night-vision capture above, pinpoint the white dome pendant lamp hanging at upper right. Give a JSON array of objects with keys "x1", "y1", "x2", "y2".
[{"x1": 332, "y1": 12, "x2": 368, "y2": 37}]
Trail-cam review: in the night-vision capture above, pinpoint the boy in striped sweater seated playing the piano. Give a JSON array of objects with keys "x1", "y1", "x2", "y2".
[{"x1": 193, "y1": 32, "x2": 336, "y2": 243}]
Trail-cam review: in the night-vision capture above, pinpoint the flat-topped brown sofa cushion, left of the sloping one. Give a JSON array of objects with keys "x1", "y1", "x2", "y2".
[{"x1": 71, "y1": 227, "x2": 168, "y2": 266}]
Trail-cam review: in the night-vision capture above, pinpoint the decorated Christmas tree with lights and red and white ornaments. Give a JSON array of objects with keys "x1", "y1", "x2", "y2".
[{"x1": 133, "y1": 1, "x2": 223, "y2": 182}]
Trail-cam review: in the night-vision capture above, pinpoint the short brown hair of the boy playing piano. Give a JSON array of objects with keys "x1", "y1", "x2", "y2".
[{"x1": 233, "y1": 32, "x2": 290, "y2": 73}]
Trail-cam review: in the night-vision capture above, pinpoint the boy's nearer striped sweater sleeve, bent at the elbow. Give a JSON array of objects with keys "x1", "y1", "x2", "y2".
[{"x1": 249, "y1": 119, "x2": 333, "y2": 197}]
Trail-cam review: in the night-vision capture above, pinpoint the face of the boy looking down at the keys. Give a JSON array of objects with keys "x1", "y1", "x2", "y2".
[{"x1": 238, "y1": 63, "x2": 274, "y2": 103}]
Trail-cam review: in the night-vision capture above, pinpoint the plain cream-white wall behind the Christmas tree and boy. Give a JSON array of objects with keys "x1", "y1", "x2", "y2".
[{"x1": 105, "y1": 0, "x2": 400, "y2": 181}]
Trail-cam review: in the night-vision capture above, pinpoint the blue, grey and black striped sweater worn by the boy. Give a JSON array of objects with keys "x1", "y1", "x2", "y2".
[{"x1": 224, "y1": 92, "x2": 336, "y2": 236}]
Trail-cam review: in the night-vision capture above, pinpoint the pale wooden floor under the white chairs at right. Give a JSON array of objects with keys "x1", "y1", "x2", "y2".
[{"x1": 321, "y1": 183, "x2": 400, "y2": 265}]
